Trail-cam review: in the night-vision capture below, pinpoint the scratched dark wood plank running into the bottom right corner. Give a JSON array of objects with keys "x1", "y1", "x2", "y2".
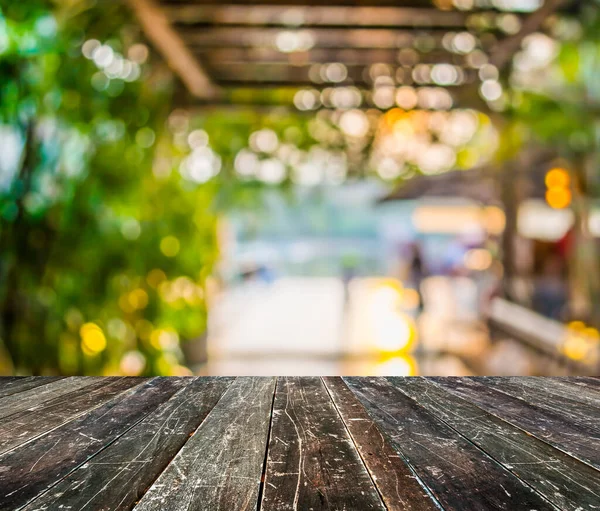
[{"x1": 388, "y1": 377, "x2": 600, "y2": 511}]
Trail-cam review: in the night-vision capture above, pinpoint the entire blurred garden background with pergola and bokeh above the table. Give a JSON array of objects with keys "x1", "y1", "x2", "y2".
[{"x1": 0, "y1": 0, "x2": 600, "y2": 375}]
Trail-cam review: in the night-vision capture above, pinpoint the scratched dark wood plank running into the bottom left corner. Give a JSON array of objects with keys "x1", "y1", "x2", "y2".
[{"x1": 0, "y1": 378, "x2": 188, "y2": 509}]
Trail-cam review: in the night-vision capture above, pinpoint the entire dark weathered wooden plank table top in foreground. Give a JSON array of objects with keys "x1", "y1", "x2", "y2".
[{"x1": 0, "y1": 377, "x2": 600, "y2": 511}]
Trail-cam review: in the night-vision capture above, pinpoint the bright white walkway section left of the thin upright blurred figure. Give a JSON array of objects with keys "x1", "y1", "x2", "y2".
[{"x1": 208, "y1": 278, "x2": 344, "y2": 375}]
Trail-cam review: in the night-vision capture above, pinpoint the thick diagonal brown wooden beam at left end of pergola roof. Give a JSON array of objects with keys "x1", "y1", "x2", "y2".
[{"x1": 127, "y1": 0, "x2": 218, "y2": 99}]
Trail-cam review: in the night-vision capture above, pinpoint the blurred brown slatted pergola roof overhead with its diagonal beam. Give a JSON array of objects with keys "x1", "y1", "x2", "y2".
[{"x1": 128, "y1": 0, "x2": 565, "y2": 109}]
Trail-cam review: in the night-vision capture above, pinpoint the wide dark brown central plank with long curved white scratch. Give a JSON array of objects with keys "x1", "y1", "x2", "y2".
[{"x1": 261, "y1": 378, "x2": 385, "y2": 511}]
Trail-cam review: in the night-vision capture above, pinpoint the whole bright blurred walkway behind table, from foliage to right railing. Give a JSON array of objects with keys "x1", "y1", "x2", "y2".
[{"x1": 198, "y1": 277, "x2": 580, "y2": 376}]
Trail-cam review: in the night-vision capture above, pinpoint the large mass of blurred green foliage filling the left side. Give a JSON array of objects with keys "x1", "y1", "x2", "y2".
[{"x1": 0, "y1": 0, "x2": 216, "y2": 374}]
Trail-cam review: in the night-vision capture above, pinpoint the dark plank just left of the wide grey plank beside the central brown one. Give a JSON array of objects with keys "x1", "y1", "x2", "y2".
[{"x1": 24, "y1": 378, "x2": 234, "y2": 511}]
